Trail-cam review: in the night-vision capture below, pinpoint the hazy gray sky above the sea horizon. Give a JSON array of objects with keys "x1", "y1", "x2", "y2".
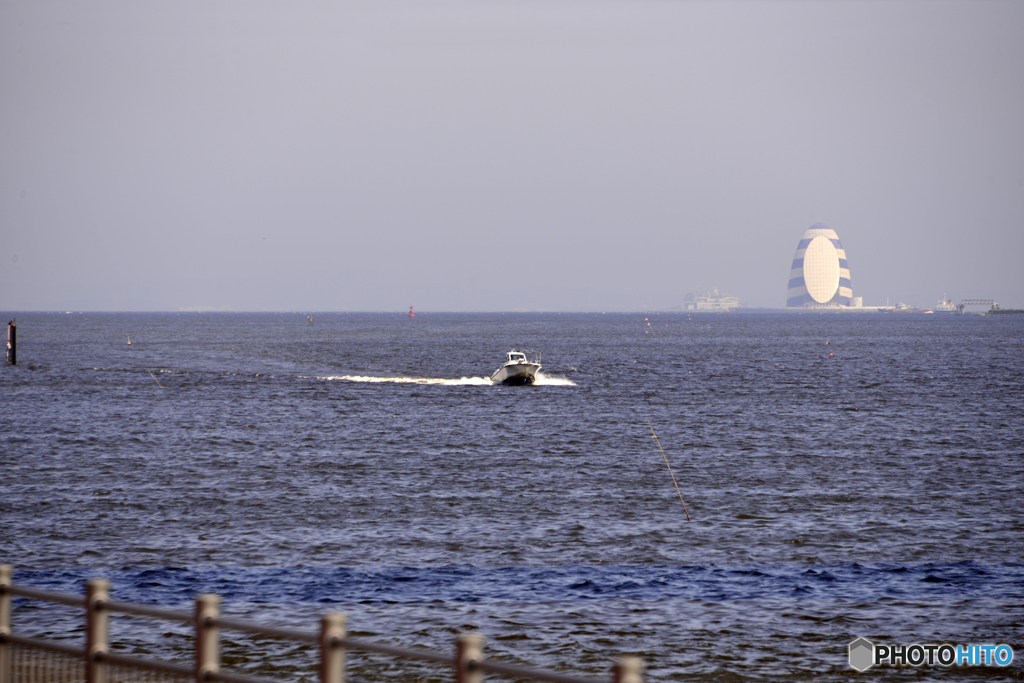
[{"x1": 0, "y1": 0, "x2": 1024, "y2": 311}]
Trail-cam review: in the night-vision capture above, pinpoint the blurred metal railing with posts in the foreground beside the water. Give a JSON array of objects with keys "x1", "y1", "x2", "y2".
[{"x1": 0, "y1": 564, "x2": 642, "y2": 683}]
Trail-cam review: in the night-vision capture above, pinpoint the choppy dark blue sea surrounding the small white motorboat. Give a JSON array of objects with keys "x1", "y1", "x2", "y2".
[{"x1": 0, "y1": 312, "x2": 1024, "y2": 681}]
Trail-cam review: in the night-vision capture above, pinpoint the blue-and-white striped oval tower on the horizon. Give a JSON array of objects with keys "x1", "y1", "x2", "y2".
[{"x1": 785, "y1": 223, "x2": 853, "y2": 308}]
